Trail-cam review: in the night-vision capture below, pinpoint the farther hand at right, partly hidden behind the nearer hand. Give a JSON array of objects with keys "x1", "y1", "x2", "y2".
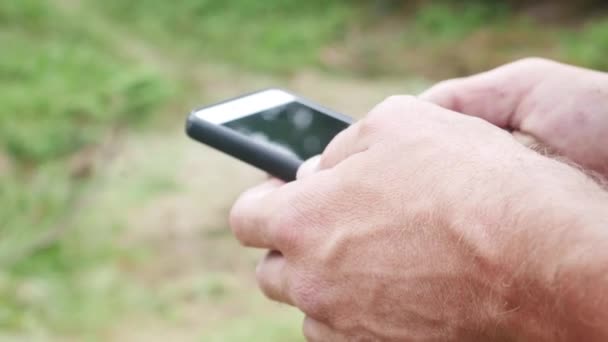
[{"x1": 420, "y1": 58, "x2": 608, "y2": 176}]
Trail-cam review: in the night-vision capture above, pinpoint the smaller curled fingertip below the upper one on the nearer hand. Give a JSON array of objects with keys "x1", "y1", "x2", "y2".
[{"x1": 256, "y1": 251, "x2": 293, "y2": 305}]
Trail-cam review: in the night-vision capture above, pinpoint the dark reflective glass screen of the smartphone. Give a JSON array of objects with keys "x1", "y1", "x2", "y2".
[{"x1": 224, "y1": 102, "x2": 348, "y2": 160}]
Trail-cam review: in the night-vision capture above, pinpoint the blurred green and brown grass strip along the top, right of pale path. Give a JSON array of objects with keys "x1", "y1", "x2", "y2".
[{"x1": 87, "y1": 0, "x2": 608, "y2": 78}]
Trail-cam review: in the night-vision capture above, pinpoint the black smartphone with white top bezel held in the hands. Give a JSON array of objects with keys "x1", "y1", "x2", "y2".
[{"x1": 186, "y1": 89, "x2": 352, "y2": 181}]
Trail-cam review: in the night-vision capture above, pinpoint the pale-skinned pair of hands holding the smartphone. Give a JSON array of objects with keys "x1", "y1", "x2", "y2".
[{"x1": 230, "y1": 59, "x2": 608, "y2": 341}]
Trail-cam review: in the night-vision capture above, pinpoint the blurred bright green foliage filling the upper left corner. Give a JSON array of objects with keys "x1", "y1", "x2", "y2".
[{"x1": 0, "y1": 0, "x2": 168, "y2": 162}]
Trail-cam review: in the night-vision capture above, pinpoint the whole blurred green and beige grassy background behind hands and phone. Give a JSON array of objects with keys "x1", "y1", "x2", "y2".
[{"x1": 0, "y1": 0, "x2": 608, "y2": 341}]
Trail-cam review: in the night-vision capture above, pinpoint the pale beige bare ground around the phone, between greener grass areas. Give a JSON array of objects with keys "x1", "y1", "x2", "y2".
[{"x1": 67, "y1": 65, "x2": 428, "y2": 341}]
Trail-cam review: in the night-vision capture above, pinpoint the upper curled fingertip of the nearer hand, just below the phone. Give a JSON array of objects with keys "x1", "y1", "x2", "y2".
[{"x1": 230, "y1": 179, "x2": 283, "y2": 249}]
